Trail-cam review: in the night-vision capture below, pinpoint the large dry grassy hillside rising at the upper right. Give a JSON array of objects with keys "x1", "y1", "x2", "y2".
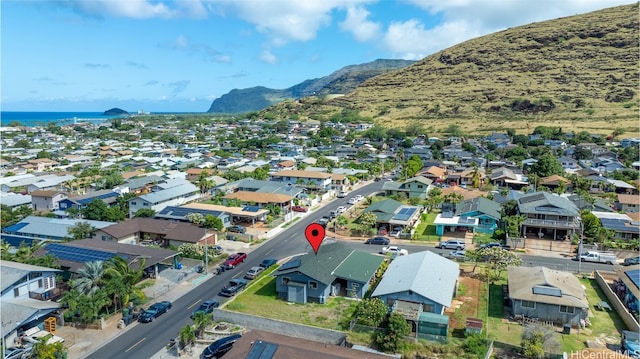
[{"x1": 267, "y1": 3, "x2": 639, "y2": 131}]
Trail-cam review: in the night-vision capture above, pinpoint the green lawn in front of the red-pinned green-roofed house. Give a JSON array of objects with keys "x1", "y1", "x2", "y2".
[{"x1": 225, "y1": 275, "x2": 356, "y2": 330}]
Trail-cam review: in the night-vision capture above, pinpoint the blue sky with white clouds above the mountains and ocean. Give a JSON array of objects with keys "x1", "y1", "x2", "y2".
[{"x1": 0, "y1": 0, "x2": 633, "y2": 112}]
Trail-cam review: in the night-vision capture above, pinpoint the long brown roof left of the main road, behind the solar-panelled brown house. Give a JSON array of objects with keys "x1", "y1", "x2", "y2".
[{"x1": 101, "y1": 218, "x2": 206, "y2": 243}]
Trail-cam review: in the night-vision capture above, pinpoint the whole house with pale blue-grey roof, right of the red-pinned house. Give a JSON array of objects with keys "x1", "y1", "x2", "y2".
[{"x1": 371, "y1": 251, "x2": 460, "y2": 337}]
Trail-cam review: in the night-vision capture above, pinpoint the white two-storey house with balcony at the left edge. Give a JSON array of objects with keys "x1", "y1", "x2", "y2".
[{"x1": 0, "y1": 260, "x2": 62, "y2": 348}]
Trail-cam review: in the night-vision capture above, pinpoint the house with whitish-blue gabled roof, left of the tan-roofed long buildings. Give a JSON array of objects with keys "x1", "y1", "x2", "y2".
[{"x1": 128, "y1": 180, "x2": 201, "y2": 218}]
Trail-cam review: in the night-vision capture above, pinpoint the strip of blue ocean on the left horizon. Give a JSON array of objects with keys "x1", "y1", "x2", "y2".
[{"x1": 0, "y1": 111, "x2": 122, "y2": 127}]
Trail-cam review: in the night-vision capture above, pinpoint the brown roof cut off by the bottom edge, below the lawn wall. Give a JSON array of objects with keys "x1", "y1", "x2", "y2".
[{"x1": 224, "y1": 330, "x2": 389, "y2": 359}]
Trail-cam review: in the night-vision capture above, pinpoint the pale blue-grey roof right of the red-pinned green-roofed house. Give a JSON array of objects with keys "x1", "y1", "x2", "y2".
[{"x1": 372, "y1": 251, "x2": 460, "y2": 307}]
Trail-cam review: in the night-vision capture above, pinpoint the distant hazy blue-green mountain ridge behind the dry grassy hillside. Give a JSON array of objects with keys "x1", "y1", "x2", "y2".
[{"x1": 207, "y1": 60, "x2": 415, "y2": 113}]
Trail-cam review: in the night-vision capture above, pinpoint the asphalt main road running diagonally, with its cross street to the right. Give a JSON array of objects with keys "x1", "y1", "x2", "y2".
[{"x1": 88, "y1": 182, "x2": 611, "y2": 359}]
